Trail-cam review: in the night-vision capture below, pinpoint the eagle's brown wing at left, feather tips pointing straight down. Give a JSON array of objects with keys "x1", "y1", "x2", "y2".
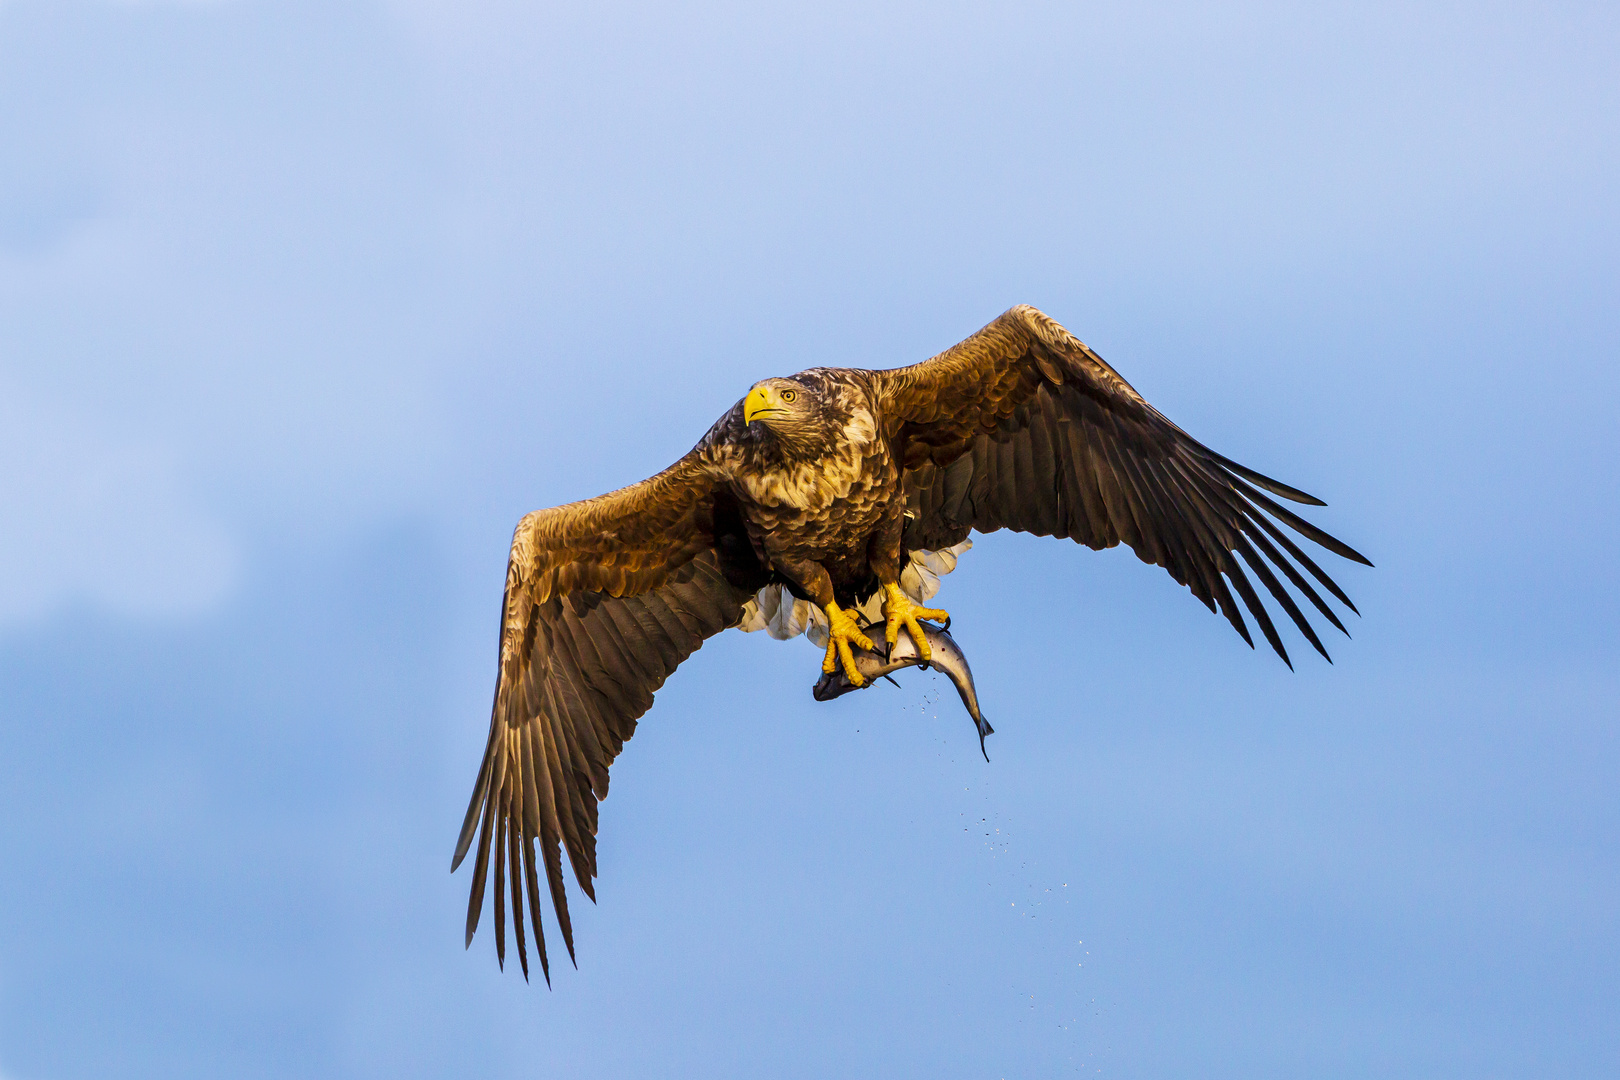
[{"x1": 450, "y1": 453, "x2": 758, "y2": 983}]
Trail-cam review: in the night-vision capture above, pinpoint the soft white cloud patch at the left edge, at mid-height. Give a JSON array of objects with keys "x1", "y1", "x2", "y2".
[{"x1": 0, "y1": 384, "x2": 237, "y2": 627}]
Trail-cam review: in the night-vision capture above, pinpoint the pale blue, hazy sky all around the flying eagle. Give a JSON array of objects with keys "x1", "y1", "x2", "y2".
[{"x1": 0, "y1": 0, "x2": 1620, "y2": 1080}]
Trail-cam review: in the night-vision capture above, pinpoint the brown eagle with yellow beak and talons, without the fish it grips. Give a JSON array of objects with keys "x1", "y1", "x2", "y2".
[{"x1": 450, "y1": 306, "x2": 1372, "y2": 984}]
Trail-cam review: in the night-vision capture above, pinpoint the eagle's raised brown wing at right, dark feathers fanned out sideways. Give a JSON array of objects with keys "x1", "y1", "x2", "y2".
[{"x1": 872, "y1": 299, "x2": 1372, "y2": 667}]
